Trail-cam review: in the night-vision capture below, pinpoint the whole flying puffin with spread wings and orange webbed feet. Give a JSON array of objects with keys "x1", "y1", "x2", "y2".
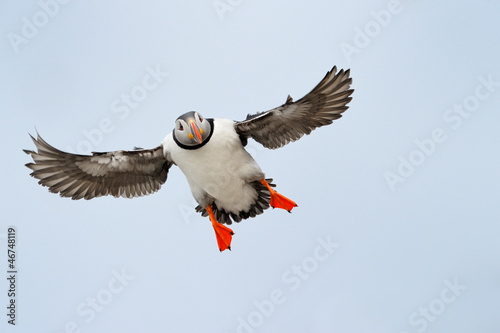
[{"x1": 24, "y1": 66, "x2": 354, "y2": 251}]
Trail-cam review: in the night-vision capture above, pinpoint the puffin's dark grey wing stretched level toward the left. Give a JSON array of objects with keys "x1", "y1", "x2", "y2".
[{"x1": 24, "y1": 135, "x2": 173, "y2": 200}]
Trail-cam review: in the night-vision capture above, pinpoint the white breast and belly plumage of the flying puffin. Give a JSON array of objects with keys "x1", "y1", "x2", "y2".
[{"x1": 164, "y1": 119, "x2": 264, "y2": 214}]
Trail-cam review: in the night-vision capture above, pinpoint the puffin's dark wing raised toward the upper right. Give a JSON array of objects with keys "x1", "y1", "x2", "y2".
[{"x1": 235, "y1": 67, "x2": 354, "y2": 149}]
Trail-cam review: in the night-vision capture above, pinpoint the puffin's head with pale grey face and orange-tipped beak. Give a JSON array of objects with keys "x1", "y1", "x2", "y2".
[{"x1": 173, "y1": 111, "x2": 213, "y2": 149}]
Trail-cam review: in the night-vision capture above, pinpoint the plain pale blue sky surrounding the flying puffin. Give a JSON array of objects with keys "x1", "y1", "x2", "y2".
[{"x1": 0, "y1": 0, "x2": 500, "y2": 333}]
